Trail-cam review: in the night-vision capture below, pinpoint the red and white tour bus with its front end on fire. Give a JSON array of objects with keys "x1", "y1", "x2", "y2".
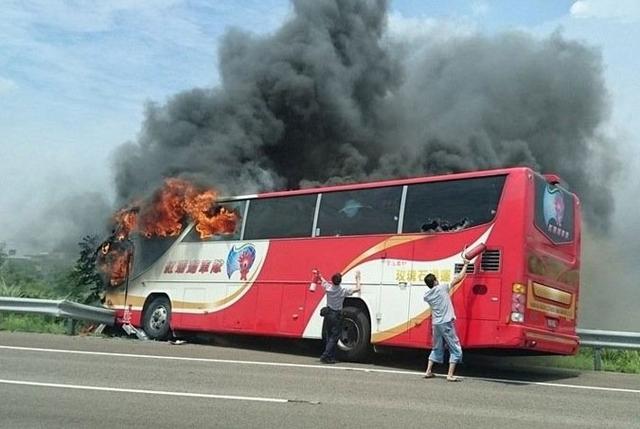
[{"x1": 105, "y1": 167, "x2": 580, "y2": 360}]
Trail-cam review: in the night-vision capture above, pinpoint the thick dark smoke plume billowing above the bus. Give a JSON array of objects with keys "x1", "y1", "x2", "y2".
[{"x1": 115, "y1": 0, "x2": 617, "y2": 229}]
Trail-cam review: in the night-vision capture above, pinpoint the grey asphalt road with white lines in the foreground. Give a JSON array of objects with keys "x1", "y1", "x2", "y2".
[{"x1": 0, "y1": 332, "x2": 640, "y2": 429}]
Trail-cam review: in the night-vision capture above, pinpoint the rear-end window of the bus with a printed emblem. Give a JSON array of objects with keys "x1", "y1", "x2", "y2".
[{"x1": 534, "y1": 175, "x2": 573, "y2": 243}]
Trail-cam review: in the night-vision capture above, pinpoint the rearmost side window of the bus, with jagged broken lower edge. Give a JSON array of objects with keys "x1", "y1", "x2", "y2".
[{"x1": 402, "y1": 176, "x2": 506, "y2": 232}]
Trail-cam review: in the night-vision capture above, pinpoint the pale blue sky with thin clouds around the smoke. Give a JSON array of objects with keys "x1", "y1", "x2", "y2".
[{"x1": 0, "y1": 0, "x2": 640, "y2": 328}]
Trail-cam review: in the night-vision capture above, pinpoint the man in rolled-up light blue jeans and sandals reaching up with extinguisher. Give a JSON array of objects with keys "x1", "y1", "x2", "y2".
[{"x1": 424, "y1": 259, "x2": 469, "y2": 381}]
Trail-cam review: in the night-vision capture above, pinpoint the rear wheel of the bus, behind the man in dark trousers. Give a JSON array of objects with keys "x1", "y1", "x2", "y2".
[{"x1": 338, "y1": 307, "x2": 371, "y2": 361}]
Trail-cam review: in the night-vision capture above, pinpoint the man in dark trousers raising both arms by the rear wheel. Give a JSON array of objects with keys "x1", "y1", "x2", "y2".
[{"x1": 320, "y1": 271, "x2": 360, "y2": 364}]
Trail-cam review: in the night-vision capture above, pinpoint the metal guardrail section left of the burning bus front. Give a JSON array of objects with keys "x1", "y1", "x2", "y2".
[{"x1": 0, "y1": 297, "x2": 115, "y2": 326}]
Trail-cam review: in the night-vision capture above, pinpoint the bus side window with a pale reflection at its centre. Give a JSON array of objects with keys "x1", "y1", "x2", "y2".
[{"x1": 316, "y1": 186, "x2": 402, "y2": 237}]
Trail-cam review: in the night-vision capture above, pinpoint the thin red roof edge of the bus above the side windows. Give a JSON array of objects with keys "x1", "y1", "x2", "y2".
[{"x1": 218, "y1": 167, "x2": 558, "y2": 202}]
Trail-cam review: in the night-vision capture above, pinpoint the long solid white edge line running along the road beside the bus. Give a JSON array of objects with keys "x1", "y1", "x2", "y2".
[{"x1": 0, "y1": 345, "x2": 640, "y2": 394}]
